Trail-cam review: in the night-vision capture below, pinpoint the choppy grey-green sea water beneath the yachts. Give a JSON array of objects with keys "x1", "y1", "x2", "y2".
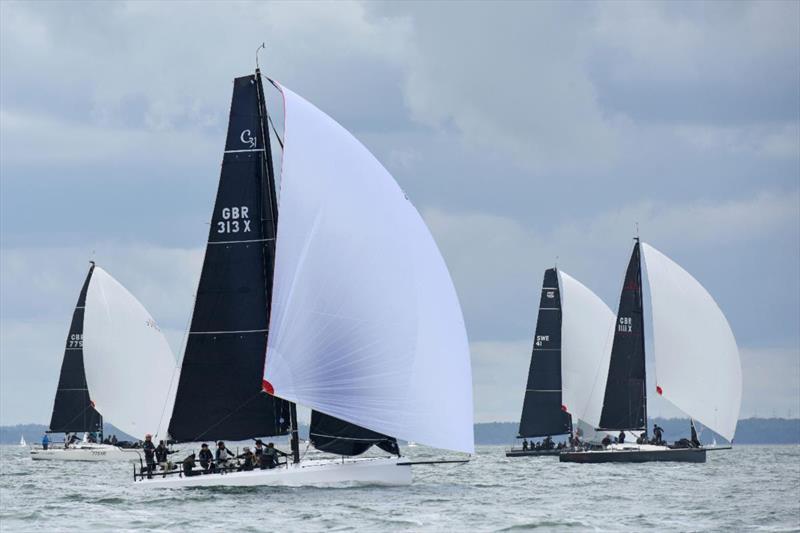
[{"x1": 0, "y1": 446, "x2": 800, "y2": 532}]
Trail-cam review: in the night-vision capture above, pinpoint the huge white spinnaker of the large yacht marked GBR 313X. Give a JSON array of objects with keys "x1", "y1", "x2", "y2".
[{"x1": 265, "y1": 83, "x2": 474, "y2": 453}]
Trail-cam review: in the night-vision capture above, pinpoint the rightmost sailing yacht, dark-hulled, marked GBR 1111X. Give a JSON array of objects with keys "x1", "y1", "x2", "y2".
[{"x1": 560, "y1": 238, "x2": 742, "y2": 463}]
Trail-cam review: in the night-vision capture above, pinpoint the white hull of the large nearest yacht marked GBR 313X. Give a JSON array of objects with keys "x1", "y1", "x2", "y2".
[{"x1": 136, "y1": 458, "x2": 411, "y2": 488}]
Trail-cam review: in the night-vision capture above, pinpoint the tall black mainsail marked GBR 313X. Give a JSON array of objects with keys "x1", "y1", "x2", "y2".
[{"x1": 169, "y1": 75, "x2": 290, "y2": 441}]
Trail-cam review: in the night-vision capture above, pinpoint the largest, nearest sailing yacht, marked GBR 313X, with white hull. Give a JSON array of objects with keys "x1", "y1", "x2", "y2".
[{"x1": 137, "y1": 63, "x2": 474, "y2": 487}]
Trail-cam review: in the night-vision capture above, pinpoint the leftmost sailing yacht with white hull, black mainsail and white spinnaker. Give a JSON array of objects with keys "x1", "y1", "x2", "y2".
[{"x1": 30, "y1": 262, "x2": 176, "y2": 461}]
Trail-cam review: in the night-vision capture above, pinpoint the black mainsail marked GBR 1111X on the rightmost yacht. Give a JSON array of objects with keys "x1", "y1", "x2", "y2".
[{"x1": 598, "y1": 238, "x2": 647, "y2": 431}]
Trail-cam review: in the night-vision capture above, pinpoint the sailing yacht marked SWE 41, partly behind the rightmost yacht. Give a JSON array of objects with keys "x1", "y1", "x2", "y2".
[{"x1": 506, "y1": 268, "x2": 614, "y2": 457}]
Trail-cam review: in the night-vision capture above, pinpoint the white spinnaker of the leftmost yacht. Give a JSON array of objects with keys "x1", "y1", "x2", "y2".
[{"x1": 83, "y1": 266, "x2": 177, "y2": 439}]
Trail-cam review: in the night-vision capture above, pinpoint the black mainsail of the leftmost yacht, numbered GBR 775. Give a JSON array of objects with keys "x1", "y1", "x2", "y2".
[{"x1": 49, "y1": 262, "x2": 103, "y2": 433}]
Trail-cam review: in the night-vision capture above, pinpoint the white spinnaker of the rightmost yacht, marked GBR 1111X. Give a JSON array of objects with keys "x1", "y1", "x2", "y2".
[{"x1": 642, "y1": 243, "x2": 742, "y2": 441}]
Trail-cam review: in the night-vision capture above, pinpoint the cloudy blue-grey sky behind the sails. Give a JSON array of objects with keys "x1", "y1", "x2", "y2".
[{"x1": 0, "y1": 1, "x2": 800, "y2": 424}]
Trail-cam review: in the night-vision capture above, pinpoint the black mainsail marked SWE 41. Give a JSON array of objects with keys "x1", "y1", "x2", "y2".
[{"x1": 519, "y1": 268, "x2": 572, "y2": 438}]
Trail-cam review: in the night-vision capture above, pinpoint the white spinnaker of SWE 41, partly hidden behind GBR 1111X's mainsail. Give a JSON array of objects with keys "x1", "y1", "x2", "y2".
[{"x1": 558, "y1": 270, "x2": 616, "y2": 428}]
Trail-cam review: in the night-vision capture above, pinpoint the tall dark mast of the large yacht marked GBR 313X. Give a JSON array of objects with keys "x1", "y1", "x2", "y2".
[{"x1": 256, "y1": 68, "x2": 300, "y2": 463}]
